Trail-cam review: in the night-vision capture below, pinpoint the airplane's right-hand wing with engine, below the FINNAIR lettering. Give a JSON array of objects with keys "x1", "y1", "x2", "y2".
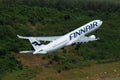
[{"x1": 75, "y1": 35, "x2": 99, "y2": 43}]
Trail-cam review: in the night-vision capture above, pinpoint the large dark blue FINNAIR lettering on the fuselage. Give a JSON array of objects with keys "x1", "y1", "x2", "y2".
[{"x1": 69, "y1": 22, "x2": 98, "y2": 40}]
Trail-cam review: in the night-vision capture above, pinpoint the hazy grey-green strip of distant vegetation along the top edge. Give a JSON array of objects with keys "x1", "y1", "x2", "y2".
[{"x1": 0, "y1": 0, "x2": 120, "y2": 12}]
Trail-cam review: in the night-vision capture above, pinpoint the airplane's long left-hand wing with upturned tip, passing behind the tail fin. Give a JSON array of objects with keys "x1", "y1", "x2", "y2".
[{"x1": 17, "y1": 35, "x2": 62, "y2": 41}]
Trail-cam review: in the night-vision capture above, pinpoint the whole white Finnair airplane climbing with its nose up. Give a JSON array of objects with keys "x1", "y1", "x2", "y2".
[{"x1": 17, "y1": 20, "x2": 103, "y2": 54}]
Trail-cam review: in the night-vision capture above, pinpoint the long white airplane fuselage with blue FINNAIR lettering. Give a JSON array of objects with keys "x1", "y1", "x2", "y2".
[{"x1": 33, "y1": 20, "x2": 102, "y2": 54}]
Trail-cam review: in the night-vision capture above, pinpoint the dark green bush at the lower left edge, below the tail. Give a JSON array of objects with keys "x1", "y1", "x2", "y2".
[{"x1": 0, "y1": 54, "x2": 22, "y2": 78}]
